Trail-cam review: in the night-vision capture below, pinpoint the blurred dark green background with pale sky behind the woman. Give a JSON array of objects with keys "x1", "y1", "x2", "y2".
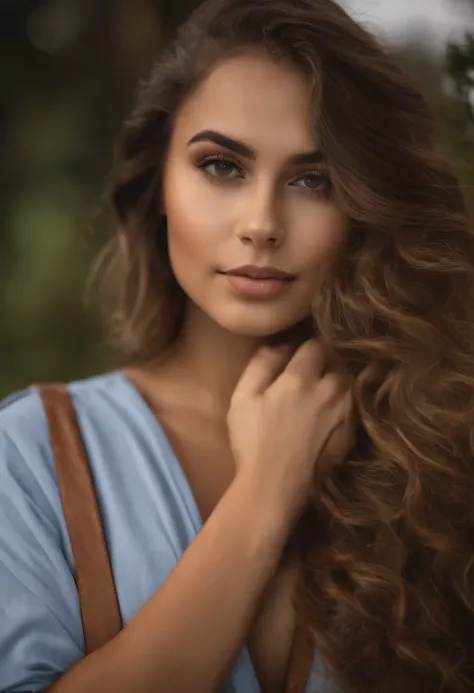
[{"x1": 0, "y1": 0, "x2": 474, "y2": 397}]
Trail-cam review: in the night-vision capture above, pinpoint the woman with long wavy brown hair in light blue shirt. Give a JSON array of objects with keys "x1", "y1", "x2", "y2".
[{"x1": 0, "y1": 0, "x2": 474, "y2": 693}]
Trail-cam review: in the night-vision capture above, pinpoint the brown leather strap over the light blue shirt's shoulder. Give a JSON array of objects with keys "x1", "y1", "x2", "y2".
[{"x1": 37, "y1": 383, "x2": 122, "y2": 654}]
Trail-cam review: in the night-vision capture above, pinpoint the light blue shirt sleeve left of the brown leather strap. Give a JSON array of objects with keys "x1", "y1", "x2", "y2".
[{"x1": 0, "y1": 389, "x2": 84, "y2": 693}]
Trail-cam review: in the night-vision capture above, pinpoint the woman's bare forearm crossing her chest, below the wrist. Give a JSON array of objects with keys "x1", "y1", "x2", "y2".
[{"x1": 48, "y1": 478, "x2": 291, "y2": 693}]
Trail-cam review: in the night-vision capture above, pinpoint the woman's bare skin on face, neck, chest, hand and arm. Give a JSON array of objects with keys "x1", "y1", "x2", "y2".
[{"x1": 51, "y1": 55, "x2": 351, "y2": 693}]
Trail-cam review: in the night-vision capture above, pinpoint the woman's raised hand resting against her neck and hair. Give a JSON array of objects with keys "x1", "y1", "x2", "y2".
[{"x1": 227, "y1": 340, "x2": 353, "y2": 524}]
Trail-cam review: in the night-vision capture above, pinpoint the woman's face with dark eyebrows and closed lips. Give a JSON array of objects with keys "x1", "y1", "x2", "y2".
[{"x1": 163, "y1": 54, "x2": 348, "y2": 338}]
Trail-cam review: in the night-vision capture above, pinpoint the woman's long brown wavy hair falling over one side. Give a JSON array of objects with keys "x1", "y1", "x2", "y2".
[{"x1": 90, "y1": 0, "x2": 474, "y2": 693}]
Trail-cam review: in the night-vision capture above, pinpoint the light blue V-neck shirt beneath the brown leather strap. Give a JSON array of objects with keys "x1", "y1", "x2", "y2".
[{"x1": 0, "y1": 372, "x2": 329, "y2": 693}]
